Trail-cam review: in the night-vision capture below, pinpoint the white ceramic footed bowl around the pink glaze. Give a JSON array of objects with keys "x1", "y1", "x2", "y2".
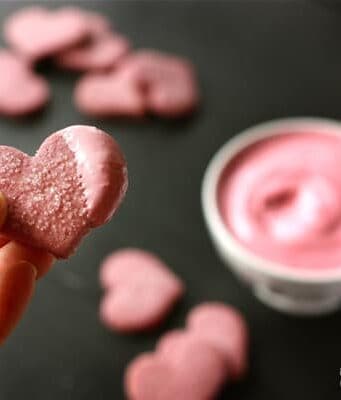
[{"x1": 202, "y1": 118, "x2": 341, "y2": 315}]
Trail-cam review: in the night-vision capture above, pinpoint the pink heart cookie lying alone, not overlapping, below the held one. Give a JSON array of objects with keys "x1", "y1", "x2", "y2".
[{"x1": 100, "y1": 249, "x2": 184, "y2": 332}]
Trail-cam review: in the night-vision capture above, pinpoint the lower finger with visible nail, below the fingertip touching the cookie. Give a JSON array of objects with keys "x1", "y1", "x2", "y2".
[{"x1": 0, "y1": 262, "x2": 36, "y2": 344}]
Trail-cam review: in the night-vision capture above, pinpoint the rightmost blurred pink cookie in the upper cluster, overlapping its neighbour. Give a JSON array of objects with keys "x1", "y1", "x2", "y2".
[{"x1": 122, "y1": 50, "x2": 199, "y2": 117}]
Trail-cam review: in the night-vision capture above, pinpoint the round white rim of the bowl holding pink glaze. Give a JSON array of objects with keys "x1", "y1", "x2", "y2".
[{"x1": 201, "y1": 117, "x2": 341, "y2": 284}]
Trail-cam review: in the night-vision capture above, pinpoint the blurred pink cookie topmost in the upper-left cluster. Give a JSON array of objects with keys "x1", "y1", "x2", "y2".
[{"x1": 4, "y1": 7, "x2": 89, "y2": 61}]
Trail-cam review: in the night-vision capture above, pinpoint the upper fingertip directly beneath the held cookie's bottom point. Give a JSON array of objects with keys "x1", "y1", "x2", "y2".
[{"x1": 0, "y1": 241, "x2": 54, "y2": 279}]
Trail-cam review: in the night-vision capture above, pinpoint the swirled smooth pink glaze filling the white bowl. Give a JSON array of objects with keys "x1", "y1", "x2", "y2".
[{"x1": 218, "y1": 129, "x2": 341, "y2": 269}]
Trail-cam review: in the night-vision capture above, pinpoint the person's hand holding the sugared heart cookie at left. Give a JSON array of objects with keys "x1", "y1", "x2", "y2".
[{"x1": 0, "y1": 192, "x2": 54, "y2": 345}]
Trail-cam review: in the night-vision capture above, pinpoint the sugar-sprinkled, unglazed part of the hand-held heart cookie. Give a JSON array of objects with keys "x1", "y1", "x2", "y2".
[{"x1": 0, "y1": 136, "x2": 88, "y2": 256}]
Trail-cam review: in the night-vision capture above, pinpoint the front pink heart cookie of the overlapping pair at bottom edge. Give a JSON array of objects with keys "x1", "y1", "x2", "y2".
[{"x1": 125, "y1": 336, "x2": 227, "y2": 400}]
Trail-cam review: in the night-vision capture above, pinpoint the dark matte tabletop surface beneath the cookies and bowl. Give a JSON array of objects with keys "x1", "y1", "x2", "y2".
[{"x1": 0, "y1": 0, "x2": 341, "y2": 400}]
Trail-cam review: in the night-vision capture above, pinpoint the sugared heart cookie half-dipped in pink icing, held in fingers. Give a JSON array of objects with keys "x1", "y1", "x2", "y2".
[{"x1": 0, "y1": 125, "x2": 127, "y2": 258}]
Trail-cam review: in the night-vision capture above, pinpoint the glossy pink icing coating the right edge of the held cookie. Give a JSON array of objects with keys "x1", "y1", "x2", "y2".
[{"x1": 60, "y1": 125, "x2": 127, "y2": 227}]
